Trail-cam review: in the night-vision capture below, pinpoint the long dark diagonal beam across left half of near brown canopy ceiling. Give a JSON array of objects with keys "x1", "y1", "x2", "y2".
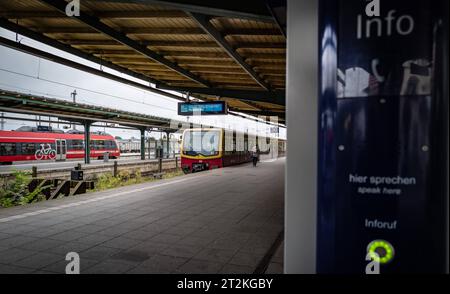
[{"x1": 39, "y1": 0, "x2": 210, "y2": 87}]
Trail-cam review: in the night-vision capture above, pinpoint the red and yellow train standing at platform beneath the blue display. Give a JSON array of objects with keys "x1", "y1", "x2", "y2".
[{"x1": 181, "y1": 128, "x2": 286, "y2": 173}]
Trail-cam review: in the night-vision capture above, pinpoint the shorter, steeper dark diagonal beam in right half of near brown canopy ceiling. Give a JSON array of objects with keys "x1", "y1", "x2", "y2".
[{"x1": 189, "y1": 13, "x2": 270, "y2": 91}]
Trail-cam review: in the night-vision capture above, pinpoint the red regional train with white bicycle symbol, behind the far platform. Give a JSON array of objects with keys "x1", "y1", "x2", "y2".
[{"x1": 0, "y1": 131, "x2": 120, "y2": 164}]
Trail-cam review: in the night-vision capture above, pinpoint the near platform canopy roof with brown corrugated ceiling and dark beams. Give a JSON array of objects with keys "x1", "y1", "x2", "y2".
[{"x1": 0, "y1": 0, "x2": 286, "y2": 117}]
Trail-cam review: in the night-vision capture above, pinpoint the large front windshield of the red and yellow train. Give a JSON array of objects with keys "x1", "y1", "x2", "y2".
[{"x1": 183, "y1": 130, "x2": 220, "y2": 156}]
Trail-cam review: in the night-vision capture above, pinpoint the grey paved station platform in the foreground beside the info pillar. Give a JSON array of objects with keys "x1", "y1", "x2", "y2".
[{"x1": 0, "y1": 158, "x2": 285, "y2": 274}]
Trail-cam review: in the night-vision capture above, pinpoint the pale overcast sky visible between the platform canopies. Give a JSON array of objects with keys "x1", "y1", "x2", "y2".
[{"x1": 0, "y1": 28, "x2": 285, "y2": 138}]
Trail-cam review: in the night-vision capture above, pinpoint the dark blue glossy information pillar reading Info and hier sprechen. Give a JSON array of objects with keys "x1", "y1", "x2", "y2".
[{"x1": 317, "y1": 0, "x2": 448, "y2": 274}]
